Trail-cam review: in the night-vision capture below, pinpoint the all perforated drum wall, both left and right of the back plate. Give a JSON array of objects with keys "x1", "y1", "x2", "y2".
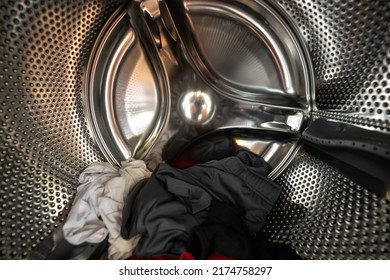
[{"x1": 0, "y1": 0, "x2": 390, "y2": 259}]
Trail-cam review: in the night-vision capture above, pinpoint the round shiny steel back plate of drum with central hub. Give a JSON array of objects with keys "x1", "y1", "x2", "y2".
[{"x1": 85, "y1": 0, "x2": 314, "y2": 176}]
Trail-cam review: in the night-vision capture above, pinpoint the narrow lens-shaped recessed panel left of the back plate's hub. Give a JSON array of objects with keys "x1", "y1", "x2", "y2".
[{"x1": 84, "y1": 11, "x2": 160, "y2": 164}]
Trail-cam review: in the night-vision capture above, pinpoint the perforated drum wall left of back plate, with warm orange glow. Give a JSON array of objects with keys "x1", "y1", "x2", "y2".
[{"x1": 0, "y1": 0, "x2": 117, "y2": 259}]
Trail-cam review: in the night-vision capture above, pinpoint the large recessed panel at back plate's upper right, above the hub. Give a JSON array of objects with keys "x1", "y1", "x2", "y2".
[{"x1": 166, "y1": 0, "x2": 313, "y2": 108}]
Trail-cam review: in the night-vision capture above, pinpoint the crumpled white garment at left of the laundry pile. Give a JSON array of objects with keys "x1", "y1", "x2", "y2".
[{"x1": 63, "y1": 159, "x2": 151, "y2": 259}]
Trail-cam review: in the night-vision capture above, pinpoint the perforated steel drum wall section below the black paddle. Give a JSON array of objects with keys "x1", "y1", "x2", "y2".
[{"x1": 264, "y1": 149, "x2": 390, "y2": 259}]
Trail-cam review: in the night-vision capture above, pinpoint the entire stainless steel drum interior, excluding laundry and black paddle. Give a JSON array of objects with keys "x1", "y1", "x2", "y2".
[{"x1": 0, "y1": 0, "x2": 390, "y2": 259}]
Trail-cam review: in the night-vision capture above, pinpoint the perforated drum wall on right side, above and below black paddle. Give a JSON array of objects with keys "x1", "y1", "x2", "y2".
[{"x1": 264, "y1": 0, "x2": 390, "y2": 259}]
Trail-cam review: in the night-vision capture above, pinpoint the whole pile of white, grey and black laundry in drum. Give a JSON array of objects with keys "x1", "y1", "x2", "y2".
[{"x1": 63, "y1": 142, "x2": 298, "y2": 259}]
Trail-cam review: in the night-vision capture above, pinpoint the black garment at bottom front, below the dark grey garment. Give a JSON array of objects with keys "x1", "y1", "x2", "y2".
[{"x1": 187, "y1": 199, "x2": 253, "y2": 260}]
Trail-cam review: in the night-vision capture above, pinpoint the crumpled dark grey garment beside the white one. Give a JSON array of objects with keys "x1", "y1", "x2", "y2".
[{"x1": 121, "y1": 150, "x2": 281, "y2": 256}]
